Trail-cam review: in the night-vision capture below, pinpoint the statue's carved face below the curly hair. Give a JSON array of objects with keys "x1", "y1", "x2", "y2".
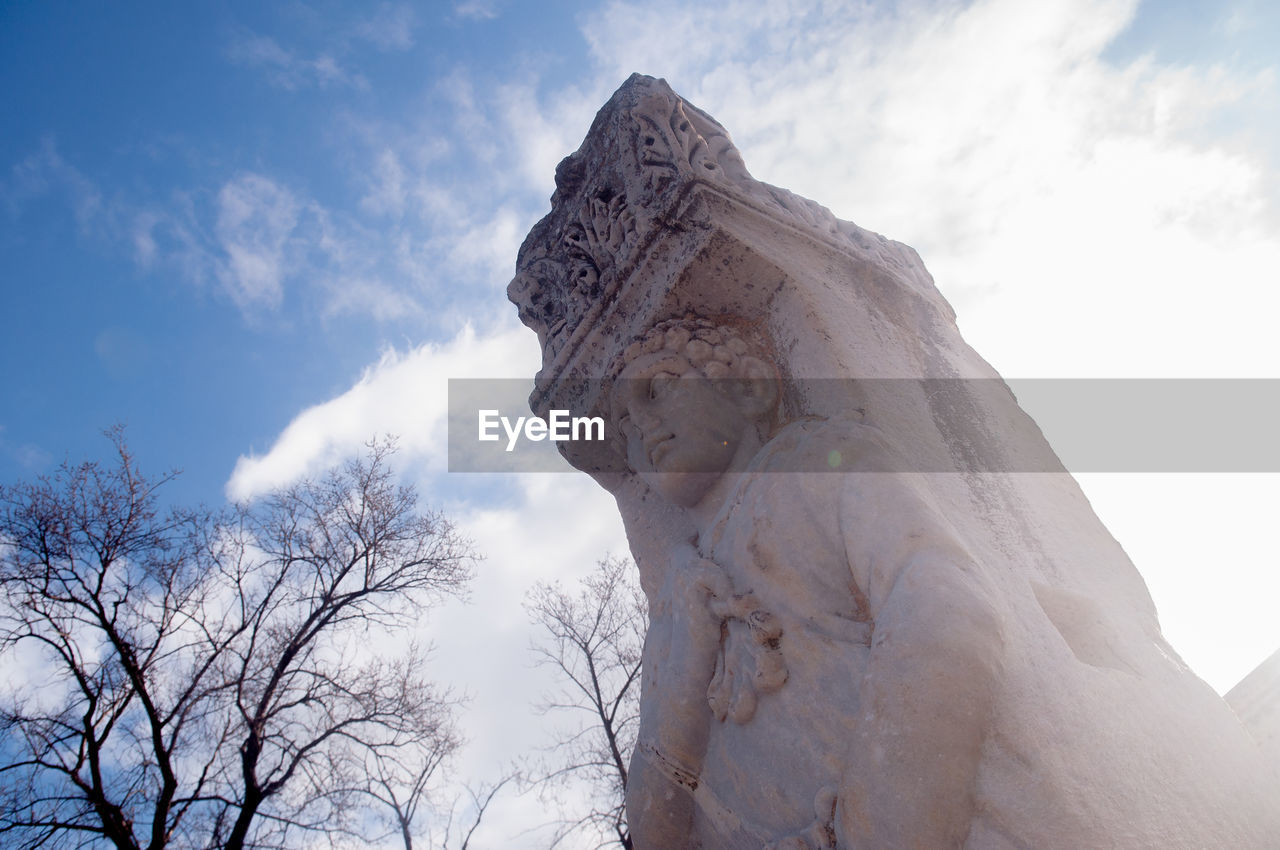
[{"x1": 613, "y1": 351, "x2": 753, "y2": 507}]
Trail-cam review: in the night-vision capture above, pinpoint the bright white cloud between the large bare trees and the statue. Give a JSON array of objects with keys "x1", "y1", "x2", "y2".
[{"x1": 227, "y1": 318, "x2": 626, "y2": 846}]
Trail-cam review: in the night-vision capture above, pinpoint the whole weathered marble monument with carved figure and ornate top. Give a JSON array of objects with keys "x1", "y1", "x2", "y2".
[{"x1": 508, "y1": 76, "x2": 1280, "y2": 850}]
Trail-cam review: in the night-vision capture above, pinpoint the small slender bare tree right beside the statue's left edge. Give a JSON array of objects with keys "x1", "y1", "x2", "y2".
[{"x1": 527, "y1": 557, "x2": 648, "y2": 850}]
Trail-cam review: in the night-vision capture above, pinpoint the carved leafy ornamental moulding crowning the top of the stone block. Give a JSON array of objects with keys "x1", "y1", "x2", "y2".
[{"x1": 507, "y1": 74, "x2": 927, "y2": 381}]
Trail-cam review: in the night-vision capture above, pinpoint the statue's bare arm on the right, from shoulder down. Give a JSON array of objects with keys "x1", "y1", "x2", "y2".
[{"x1": 837, "y1": 474, "x2": 1004, "y2": 847}]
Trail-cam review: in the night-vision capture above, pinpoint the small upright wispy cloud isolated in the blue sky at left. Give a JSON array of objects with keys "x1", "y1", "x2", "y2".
[{"x1": 215, "y1": 174, "x2": 298, "y2": 310}]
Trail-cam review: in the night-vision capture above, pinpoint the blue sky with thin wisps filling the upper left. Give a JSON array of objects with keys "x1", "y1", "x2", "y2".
[{"x1": 0, "y1": 4, "x2": 584, "y2": 501}]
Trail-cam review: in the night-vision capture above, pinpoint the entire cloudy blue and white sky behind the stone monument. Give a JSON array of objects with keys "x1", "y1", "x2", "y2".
[{"x1": 0, "y1": 0, "x2": 1280, "y2": 846}]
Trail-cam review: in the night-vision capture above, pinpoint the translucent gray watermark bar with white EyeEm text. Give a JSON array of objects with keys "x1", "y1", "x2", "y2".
[{"x1": 448, "y1": 375, "x2": 1280, "y2": 472}]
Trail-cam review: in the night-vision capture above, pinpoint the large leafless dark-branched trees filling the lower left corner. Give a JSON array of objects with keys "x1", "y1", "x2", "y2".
[{"x1": 0, "y1": 430, "x2": 472, "y2": 850}]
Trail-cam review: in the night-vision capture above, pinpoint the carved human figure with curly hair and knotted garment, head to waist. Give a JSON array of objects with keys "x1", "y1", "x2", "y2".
[{"x1": 614, "y1": 314, "x2": 1002, "y2": 847}]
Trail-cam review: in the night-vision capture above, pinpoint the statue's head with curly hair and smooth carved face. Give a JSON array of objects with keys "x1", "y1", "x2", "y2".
[{"x1": 611, "y1": 317, "x2": 778, "y2": 507}]
